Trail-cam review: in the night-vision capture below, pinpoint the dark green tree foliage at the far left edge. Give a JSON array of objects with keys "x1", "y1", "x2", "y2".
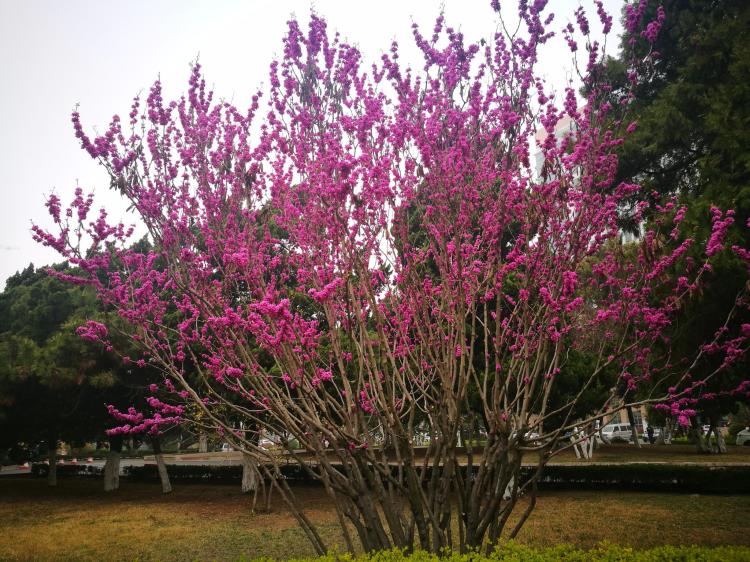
[{"x1": 0, "y1": 263, "x2": 119, "y2": 454}]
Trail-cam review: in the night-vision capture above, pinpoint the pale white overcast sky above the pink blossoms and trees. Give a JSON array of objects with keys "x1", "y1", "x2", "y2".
[{"x1": 0, "y1": 0, "x2": 622, "y2": 288}]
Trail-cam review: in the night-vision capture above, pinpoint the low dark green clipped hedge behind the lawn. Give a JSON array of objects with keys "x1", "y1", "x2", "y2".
[{"x1": 126, "y1": 463, "x2": 750, "y2": 494}]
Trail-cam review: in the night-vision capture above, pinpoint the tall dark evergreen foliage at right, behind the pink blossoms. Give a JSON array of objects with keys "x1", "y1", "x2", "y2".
[{"x1": 604, "y1": 0, "x2": 750, "y2": 421}]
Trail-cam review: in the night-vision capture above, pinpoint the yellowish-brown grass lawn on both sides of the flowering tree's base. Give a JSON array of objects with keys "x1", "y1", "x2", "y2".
[{"x1": 0, "y1": 477, "x2": 750, "y2": 561}]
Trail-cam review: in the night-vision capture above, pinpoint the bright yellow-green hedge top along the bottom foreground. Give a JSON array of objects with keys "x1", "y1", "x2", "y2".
[{"x1": 240, "y1": 543, "x2": 750, "y2": 562}]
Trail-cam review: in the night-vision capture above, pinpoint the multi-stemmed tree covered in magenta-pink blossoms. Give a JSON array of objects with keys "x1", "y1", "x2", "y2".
[{"x1": 35, "y1": 1, "x2": 750, "y2": 552}]
